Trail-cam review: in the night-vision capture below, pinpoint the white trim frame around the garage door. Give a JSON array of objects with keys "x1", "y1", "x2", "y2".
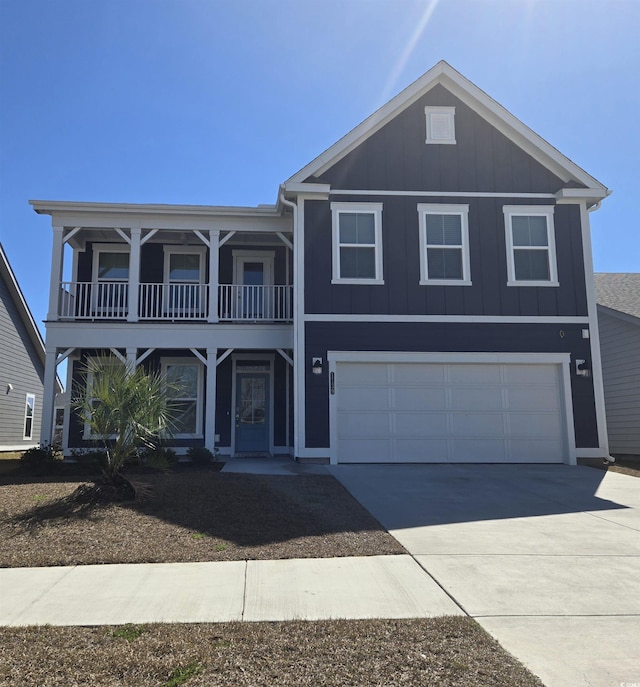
[{"x1": 327, "y1": 351, "x2": 576, "y2": 465}]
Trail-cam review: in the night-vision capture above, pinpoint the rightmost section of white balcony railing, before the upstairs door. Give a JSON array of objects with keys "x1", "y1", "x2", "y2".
[{"x1": 218, "y1": 284, "x2": 293, "y2": 322}]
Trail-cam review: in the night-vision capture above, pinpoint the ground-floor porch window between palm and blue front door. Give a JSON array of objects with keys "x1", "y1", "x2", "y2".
[{"x1": 162, "y1": 358, "x2": 203, "y2": 438}]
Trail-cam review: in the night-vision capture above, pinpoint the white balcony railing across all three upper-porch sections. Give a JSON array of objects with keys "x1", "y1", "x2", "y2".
[{"x1": 58, "y1": 281, "x2": 293, "y2": 323}]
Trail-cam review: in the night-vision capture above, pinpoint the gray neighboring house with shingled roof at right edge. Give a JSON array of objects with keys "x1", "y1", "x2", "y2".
[{"x1": 595, "y1": 273, "x2": 640, "y2": 455}]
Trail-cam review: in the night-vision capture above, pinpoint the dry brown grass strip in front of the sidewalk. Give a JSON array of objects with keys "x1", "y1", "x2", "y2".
[{"x1": 0, "y1": 617, "x2": 542, "y2": 687}]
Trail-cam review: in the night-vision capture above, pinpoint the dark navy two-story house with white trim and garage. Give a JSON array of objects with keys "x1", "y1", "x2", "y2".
[{"x1": 32, "y1": 62, "x2": 609, "y2": 463}]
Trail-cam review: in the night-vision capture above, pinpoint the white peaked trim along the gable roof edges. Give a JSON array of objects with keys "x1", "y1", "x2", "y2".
[{"x1": 285, "y1": 61, "x2": 609, "y2": 199}]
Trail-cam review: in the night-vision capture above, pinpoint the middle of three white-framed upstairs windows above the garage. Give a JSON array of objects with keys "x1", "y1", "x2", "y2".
[{"x1": 418, "y1": 203, "x2": 471, "y2": 286}]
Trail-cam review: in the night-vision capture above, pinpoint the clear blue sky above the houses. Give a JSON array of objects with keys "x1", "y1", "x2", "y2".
[{"x1": 0, "y1": 0, "x2": 640, "y2": 334}]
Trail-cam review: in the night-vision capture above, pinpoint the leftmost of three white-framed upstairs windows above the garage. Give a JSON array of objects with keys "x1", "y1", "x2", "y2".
[{"x1": 331, "y1": 203, "x2": 384, "y2": 284}]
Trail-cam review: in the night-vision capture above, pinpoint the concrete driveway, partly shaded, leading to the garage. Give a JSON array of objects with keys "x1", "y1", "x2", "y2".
[{"x1": 329, "y1": 465, "x2": 640, "y2": 687}]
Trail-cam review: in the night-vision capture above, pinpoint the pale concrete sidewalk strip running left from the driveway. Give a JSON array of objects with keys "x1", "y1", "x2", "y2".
[{"x1": 0, "y1": 555, "x2": 464, "y2": 626}]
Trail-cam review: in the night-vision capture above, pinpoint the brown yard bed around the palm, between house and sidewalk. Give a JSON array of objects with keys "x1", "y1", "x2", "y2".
[{"x1": 0, "y1": 468, "x2": 406, "y2": 567}]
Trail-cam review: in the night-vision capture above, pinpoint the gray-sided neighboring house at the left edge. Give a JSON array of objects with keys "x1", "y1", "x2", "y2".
[{"x1": 0, "y1": 244, "x2": 45, "y2": 451}]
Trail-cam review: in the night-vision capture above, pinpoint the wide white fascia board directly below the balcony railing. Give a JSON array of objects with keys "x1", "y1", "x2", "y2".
[{"x1": 46, "y1": 321, "x2": 293, "y2": 350}]
